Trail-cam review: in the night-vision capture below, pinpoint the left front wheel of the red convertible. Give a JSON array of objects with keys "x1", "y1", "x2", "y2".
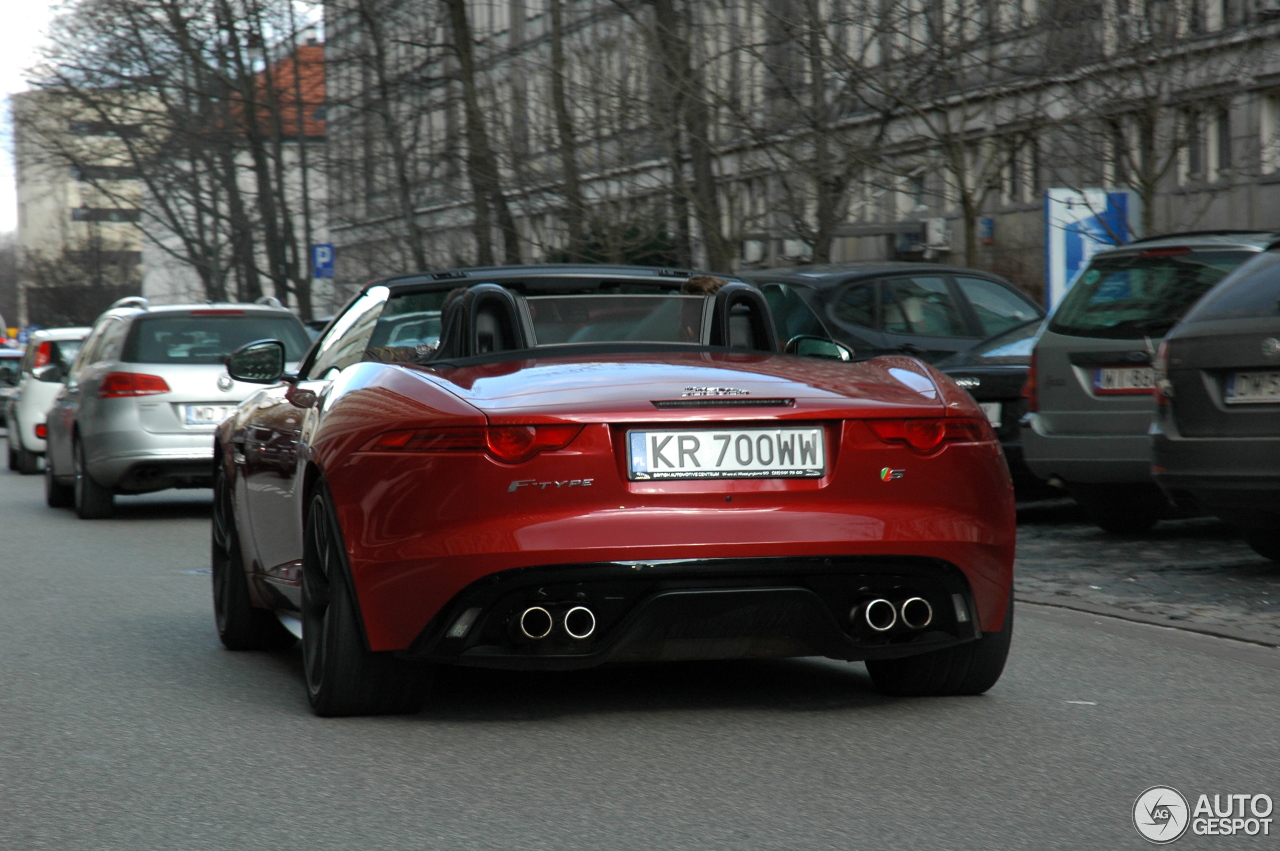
[{"x1": 210, "y1": 462, "x2": 297, "y2": 650}]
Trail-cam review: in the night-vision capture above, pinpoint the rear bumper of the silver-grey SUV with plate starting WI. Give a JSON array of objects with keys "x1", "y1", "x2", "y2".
[{"x1": 1021, "y1": 413, "x2": 1151, "y2": 484}]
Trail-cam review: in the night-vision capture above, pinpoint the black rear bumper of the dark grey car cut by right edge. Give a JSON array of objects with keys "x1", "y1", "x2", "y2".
[{"x1": 1152, "y1": 426, "x2": 1280, "y2": 527}]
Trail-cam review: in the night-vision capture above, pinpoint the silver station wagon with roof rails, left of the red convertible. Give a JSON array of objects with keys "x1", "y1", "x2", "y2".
[{"x1": 45, "y1": 291, "x2": 310, "y2": 518}]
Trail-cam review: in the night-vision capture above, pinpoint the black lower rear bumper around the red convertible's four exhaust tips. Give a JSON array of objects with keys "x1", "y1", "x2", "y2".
[{"x1": 404, "y1": 557, "x2": 980, "y2": 669}]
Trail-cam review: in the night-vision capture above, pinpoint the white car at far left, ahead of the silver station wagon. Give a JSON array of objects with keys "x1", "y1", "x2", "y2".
[{"x1": 5, "y1": 328, "x2": 90, "y2": 476}]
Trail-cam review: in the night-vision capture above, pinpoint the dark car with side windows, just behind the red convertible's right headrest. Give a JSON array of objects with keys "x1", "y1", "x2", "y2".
[{"x1": 739, "y1": 261, "x2": 1044, "y2": 361}]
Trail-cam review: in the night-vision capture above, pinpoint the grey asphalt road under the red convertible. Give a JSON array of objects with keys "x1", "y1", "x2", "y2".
[{"x1": 0, "y1": 460, "x2": 1280, "y2": 851}]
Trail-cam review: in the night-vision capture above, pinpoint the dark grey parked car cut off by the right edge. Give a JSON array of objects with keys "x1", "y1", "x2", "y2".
[{"x1": 1151, "y1": 246, "x2": 1280, "y2": 562}]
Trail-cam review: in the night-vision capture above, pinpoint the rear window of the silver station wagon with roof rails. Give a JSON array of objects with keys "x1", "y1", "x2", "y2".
[{"x1": 122, "y1": 314, "x2": 310, "y2": 363}]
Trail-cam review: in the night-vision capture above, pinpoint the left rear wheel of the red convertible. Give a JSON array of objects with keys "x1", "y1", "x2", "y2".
[{"x1": 302, "y1": 493, "x2": 431, "y2": 717}]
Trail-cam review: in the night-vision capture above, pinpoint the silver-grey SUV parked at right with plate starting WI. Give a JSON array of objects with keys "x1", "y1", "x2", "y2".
[{"x1": 1023, "y1": 232, "x2": 1280, "y2": 532}]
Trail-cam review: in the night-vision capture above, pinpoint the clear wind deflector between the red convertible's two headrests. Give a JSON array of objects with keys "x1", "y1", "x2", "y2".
[{"x1": 526, "y1": 296, "x2": 709, "y2": 346}]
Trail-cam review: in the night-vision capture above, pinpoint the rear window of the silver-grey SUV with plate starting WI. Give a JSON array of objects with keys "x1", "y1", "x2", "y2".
[{"x1": 1050, "y1": 248, "x2": 1257, "y2": 339}]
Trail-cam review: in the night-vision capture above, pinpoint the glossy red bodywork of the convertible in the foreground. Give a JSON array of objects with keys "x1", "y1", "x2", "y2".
[{"x1": 247, "y1": 352, "x2": 1015, "y2": 650}]
